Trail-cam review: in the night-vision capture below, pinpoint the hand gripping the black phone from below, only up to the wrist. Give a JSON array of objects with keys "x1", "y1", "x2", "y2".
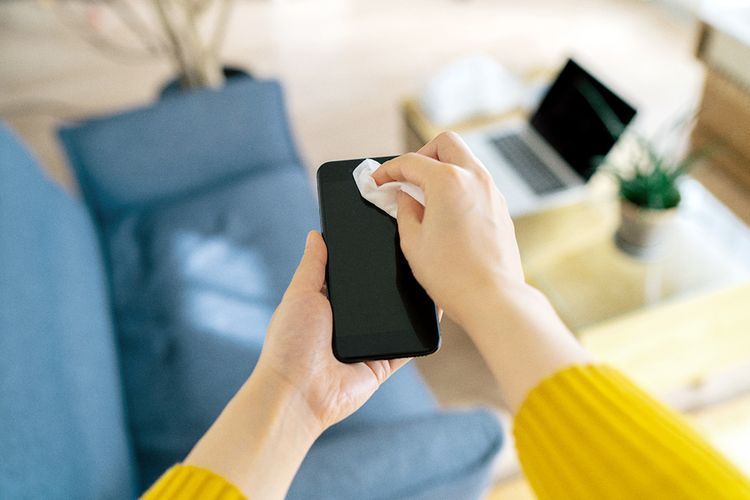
[{"x1": 256, "y1": 231, "x2": 409, "y2": 432}]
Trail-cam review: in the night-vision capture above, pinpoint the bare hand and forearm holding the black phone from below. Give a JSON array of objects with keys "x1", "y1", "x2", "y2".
[{"x1": 184, "y1": 232, "x2": 408, "y2": 500}]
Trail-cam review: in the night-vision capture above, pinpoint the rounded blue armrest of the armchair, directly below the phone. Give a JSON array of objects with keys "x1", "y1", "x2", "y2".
[{"x1": 288, "y1": 410, "x2": 502, "y2": 500}]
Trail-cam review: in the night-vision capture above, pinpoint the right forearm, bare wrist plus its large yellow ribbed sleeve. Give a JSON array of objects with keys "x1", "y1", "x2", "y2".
[{"x1": 462, "y1": 284, "x2": 750, "y2": 499}]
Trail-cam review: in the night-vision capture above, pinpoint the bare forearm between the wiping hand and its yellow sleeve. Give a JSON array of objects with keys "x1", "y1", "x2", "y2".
[{"x1": 459, "y1": 283, "x2": 591, "y2": 413}]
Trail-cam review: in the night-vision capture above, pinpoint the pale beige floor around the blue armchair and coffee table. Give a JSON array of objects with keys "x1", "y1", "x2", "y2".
[{"x1": 0, "y1": 0, "x2": 736, "y2": 499}]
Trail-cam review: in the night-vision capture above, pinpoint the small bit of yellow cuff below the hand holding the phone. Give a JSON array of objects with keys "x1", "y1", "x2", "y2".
[{"x1": 141, "y1": 465, "x2": 246, "y2": 500}]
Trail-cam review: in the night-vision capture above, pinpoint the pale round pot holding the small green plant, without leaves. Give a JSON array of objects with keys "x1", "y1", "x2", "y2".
[{"x1": 615, "y1": 200, "x2": 677, "y2": 259}]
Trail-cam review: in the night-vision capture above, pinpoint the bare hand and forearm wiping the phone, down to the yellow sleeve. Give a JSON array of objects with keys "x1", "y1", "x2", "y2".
[{"x1": 373, "y1": 133, "x2": 590, "y2": 411}]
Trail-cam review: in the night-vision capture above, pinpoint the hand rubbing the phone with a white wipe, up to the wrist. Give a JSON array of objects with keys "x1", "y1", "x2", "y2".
[{"x1": 373, "y1": 132, "x2": 525, "y2": 323}]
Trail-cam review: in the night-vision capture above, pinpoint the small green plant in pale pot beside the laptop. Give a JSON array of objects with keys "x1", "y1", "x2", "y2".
[{"x1": 607, "y1": 138, "x2": 702, "y2": 258}]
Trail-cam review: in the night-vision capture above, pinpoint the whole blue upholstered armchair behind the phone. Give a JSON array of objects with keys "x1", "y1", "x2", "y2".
[{"x1": 0, "y1": 79, "x2": 501, "y2": 499}]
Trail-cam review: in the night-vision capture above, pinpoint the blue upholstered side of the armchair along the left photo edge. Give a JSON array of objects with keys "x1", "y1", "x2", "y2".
[{"x1": 0, "y1": 124, "x2": 135, "y2": 499}]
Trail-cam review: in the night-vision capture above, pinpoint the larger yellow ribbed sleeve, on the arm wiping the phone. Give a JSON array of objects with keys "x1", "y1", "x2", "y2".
[{"x1": 514, "y1": 365, "x2": 750, "y2": 500}]
